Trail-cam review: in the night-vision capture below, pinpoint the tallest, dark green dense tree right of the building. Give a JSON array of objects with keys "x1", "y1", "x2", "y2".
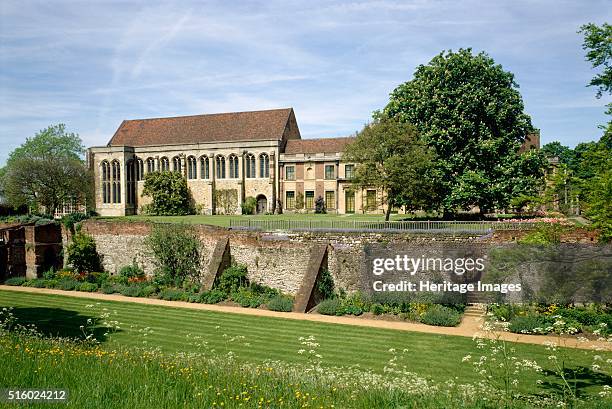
[{"x1": 384, "y1": 49, "x2": 546, "y2": 214}]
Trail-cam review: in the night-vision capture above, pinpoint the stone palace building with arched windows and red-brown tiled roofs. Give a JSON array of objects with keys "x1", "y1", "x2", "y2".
[{"x1": 87, "y1": 108, "x2": 382, "y2": 216}]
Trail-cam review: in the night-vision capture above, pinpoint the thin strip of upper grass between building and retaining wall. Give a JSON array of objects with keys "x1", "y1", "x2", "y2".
[{"x1": 96, "y1": 213, "x2": 407, "y2": 227}]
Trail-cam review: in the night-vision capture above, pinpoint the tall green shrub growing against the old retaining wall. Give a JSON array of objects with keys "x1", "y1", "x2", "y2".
[{"x1": 145, "y1": 224, "x2": 201, "y2": 286}]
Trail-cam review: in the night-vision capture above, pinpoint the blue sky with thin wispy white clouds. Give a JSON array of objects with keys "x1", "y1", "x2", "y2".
[{"x1": 0, "y1": 0, "x2": 612, "y2": 164}]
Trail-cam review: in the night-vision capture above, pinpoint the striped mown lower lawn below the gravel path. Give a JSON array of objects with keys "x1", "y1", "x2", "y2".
[{"x1": 0, "y1": 291, "x2": 608, "y2": 390}]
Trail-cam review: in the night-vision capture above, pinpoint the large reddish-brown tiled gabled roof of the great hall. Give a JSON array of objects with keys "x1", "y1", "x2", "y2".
[{"x1": 108, "y1": 108, "x2": 299, "y2": 146}]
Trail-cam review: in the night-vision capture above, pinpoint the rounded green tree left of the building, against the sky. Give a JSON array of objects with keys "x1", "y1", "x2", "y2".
[{"x1": 0, "y1": 124, "x2": 92, "y2": 214}]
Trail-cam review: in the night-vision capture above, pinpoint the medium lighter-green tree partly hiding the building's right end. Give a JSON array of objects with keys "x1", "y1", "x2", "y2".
[{"x1": 342, "y1": 116, "x2": 435, "y2": 220}]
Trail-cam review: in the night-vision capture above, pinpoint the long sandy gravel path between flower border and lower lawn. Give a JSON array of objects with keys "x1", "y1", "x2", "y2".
[{"x1": 0, "y1": 285, "x2": 612, "y2": 351}]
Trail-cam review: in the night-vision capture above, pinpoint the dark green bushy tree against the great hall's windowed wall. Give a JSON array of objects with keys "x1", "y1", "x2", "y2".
[{"x1": 142, "y1": 172, "x2": 193, "y2": 216}]
